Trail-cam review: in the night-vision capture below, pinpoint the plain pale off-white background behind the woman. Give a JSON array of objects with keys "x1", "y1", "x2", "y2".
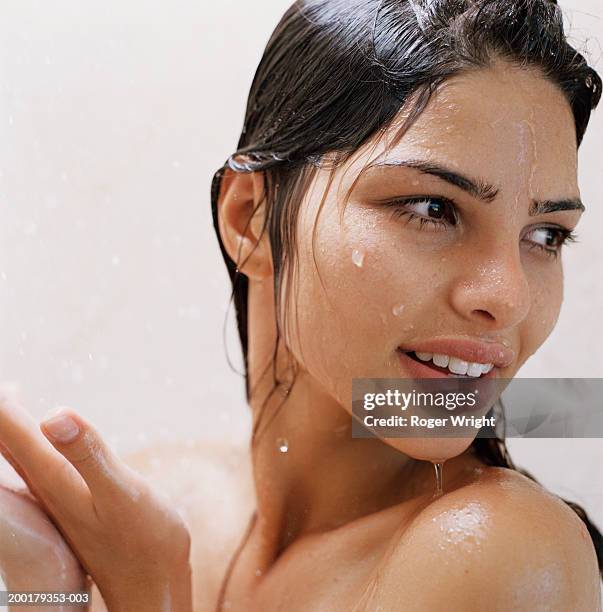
[{"x1": 0, "y1": 0, "x2": 603, "y2": 540}]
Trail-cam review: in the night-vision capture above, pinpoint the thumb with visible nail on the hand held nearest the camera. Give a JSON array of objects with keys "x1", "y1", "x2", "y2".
[{"x1": 40, "y1": 408, "x2": 142, "y2": 506}]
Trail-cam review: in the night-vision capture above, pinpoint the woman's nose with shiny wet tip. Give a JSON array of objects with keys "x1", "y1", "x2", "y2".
[{"x1": 451, "y1": 241, "x2": 530, "y2": 329}]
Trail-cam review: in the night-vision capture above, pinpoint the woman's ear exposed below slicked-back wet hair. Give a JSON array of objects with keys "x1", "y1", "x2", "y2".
[{"x1": 218, "y1": 168, "x2": 273, "y2": 280}]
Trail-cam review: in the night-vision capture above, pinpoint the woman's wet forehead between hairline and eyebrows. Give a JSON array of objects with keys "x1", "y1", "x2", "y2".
[{"x1": 346, "y1": 62, "x2": 577, "y2": 197}]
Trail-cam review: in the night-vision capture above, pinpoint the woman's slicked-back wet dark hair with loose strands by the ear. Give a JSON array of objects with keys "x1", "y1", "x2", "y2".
[{"x1": 211, "y1": 0, "x2": 603, "y2": 596}]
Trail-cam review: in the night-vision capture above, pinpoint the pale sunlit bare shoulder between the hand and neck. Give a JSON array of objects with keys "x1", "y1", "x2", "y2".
[{"x1": 124, "y1": 441, "x2": 255, "y2": 611}]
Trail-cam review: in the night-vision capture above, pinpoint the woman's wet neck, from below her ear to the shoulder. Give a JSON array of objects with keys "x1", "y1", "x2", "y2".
[{"x1": 248, "y1": 283, "x2": 434, "y2": 565}]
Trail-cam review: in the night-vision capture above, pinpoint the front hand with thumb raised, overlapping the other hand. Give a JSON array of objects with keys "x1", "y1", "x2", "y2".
[{"x1": 0, "y1": 387, "x2": 192, "y2": 612}]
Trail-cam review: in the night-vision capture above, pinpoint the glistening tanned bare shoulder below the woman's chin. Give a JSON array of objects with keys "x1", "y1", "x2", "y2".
[{"x1": 373, "y1": 468, "x2": 601, "y2": 612}]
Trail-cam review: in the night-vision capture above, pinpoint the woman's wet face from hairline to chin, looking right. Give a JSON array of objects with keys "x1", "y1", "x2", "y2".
[{"x1": 286, "y1": 62, "x2": 581, "y2": 458}]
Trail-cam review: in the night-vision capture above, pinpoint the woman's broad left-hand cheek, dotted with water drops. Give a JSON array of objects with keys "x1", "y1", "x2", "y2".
[{"x1": 286, "y1": 203, "x2": 437, "y2": 406}]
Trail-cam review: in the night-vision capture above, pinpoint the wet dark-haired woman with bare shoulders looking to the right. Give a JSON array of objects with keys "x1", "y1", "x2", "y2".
[{"x1": 0, "y1": 0, "x2": 602, "y2": 611}]
